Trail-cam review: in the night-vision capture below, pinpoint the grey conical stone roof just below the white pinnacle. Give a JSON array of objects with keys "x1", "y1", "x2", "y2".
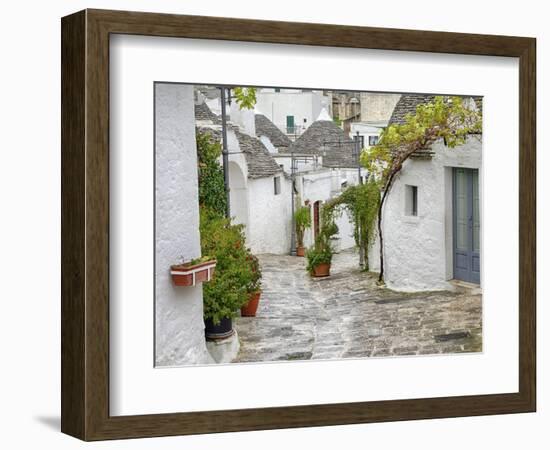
[{"x1": 288, "y1": 120, "x2": 357, "y2": 167}]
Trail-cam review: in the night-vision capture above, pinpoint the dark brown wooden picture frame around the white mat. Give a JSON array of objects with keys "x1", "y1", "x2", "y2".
[{"x1": 61, "y1": 10, "x2": 536, "y2": 440}]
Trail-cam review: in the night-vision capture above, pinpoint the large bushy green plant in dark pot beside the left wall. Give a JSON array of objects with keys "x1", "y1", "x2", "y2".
[{"x1": 200, "y1": 207, "x2": 254, "y2": 340}]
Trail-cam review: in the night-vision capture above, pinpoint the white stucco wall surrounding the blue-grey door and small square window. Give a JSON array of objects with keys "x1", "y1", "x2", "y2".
[{"x1": 369, "y1": 137, "x2": 483, "y2": 291}]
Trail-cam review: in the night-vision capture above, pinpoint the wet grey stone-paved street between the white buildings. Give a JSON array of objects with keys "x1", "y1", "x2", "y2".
[{"x1": 234, "y1": 251, "x2": 481, "y2": 362}]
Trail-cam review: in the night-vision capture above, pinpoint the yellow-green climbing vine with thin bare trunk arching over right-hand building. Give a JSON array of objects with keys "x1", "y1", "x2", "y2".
[{"x1": 361, "y1": 96, "x2": 482, "y2": 283}]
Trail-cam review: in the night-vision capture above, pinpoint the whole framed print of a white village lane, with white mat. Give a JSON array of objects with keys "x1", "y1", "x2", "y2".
[{"x1": 62, "y1": 10, "x2": 536, "y2": 440}]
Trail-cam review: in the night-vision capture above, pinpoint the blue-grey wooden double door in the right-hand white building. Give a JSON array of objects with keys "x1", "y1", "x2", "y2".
[{"x1": 453, "y1": 168, "x2": 481, "y2": 284}]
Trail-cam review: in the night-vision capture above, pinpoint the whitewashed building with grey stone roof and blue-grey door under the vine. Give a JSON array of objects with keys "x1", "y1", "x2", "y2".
[{"x1": 369, "y1": 94, "x2": 483, "y2": 291}]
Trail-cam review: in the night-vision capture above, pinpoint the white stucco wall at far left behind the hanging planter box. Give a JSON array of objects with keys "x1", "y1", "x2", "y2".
[{"x1": 155, "y1": 84, "x2": 215, "y2": 366}]
